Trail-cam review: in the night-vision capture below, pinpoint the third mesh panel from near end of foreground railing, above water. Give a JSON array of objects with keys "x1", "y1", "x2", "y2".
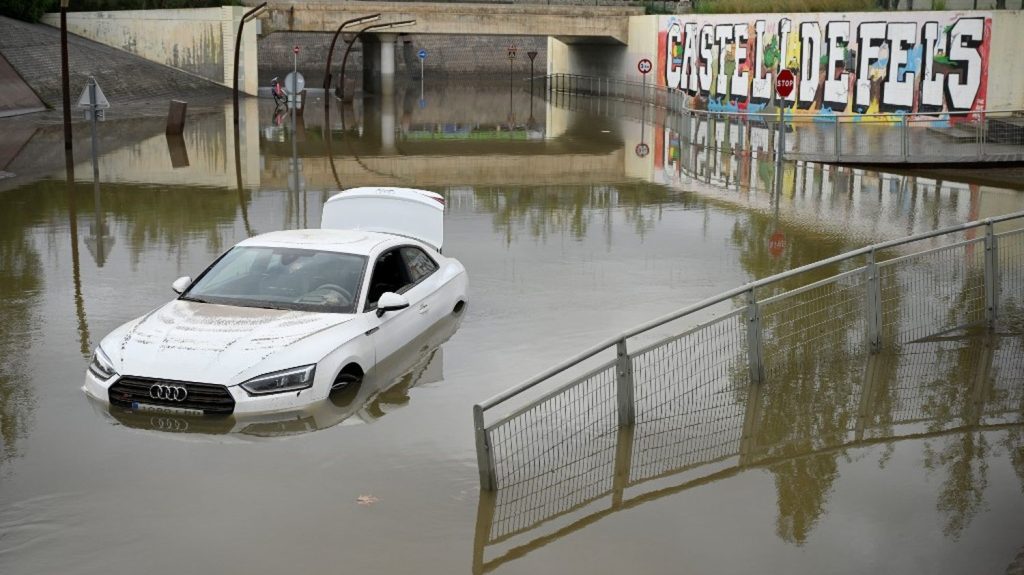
[{"x1": 761, "y1": 268, "x2": 867, "y2": 381}]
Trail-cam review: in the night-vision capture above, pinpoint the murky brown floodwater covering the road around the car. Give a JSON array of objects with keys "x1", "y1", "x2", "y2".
[{"x1": 0, "y1": 82, "x2": 1024, "y2": 575}]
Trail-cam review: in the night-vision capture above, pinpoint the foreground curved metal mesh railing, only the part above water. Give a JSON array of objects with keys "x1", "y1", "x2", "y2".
[{"x1": 473, "y1": 212, "x2": 1024, "y2": 490}]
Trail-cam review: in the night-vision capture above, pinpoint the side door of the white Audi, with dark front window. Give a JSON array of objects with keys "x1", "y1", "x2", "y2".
[{"x1": 364, "y1": 247, "x2": 430, "y2": 363}]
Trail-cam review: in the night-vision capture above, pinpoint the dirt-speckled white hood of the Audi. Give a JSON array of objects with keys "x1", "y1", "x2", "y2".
[{"x1": 104, "y1": 300, "x2": 353, "y2": 385}]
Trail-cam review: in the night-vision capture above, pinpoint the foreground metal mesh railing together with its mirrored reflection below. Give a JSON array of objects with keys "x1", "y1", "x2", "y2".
[{"x1": 474, "y1": 207, "x2": 1024, "y2": 552}]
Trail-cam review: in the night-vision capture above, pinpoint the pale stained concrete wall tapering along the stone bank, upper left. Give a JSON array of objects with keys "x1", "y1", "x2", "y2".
[{"x1": 43, "y1": 6, "x2": 259, "y2": 94}]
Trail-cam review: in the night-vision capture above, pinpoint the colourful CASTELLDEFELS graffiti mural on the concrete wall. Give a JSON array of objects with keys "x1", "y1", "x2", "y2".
[{"x1": 657, "y1": 12, "x2": 992, "y2": 115}]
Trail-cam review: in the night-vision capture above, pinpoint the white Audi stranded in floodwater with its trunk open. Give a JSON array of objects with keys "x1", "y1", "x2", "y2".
[{"x1": 83, "y1": 188, "x2": 467, "y2": 414}]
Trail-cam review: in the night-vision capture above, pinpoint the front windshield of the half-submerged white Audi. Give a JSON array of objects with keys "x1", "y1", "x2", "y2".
[{"x1": 181, "y1": 247, "x2": 367, "y2": 313}]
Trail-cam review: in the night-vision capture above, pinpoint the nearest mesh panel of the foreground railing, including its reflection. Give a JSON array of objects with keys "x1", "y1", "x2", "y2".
[{"x1": 487, "y1": 364, "x2": 617, "y2": 538}]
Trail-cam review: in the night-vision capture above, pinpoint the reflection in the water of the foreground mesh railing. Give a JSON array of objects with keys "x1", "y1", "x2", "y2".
[{"x1": 473, "y1": 334, "x2": 1024, "y2": 573}]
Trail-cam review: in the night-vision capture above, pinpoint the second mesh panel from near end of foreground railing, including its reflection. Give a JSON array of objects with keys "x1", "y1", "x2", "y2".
[{"x1": 630, "y1": 309, "x2": 750, "y2": 482}]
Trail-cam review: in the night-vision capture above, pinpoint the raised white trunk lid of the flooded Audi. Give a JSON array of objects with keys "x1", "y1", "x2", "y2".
[{"x1": 321, "y1": 187, "x2": 444, "y2": 251}]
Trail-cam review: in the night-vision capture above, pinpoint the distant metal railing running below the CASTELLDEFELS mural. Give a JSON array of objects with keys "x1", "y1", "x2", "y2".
[{"x1": 534, "y1": 74, "x2": 1024, "y2": 164}]
